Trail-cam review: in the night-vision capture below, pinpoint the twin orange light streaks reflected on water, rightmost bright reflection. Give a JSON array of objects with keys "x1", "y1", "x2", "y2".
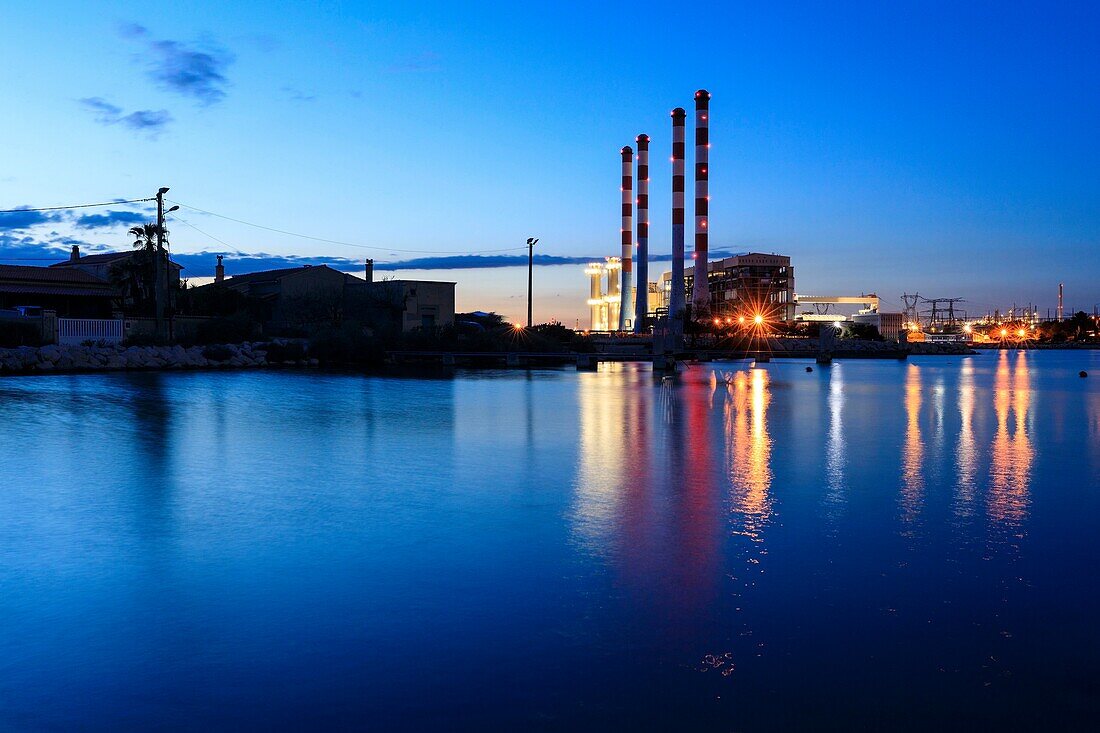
[{"x1": 988, "y1": 351, "x2": 1035, "y2": 525}]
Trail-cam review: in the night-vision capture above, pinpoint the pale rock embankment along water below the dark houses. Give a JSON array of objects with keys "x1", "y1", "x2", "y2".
[{"x1": 0, "y1": 341, "x2": 318, "y2": 374}]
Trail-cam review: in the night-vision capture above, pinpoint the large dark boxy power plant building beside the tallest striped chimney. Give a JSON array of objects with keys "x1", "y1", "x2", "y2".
[{"x1": 659, "y1": 252, "x2": 795, "y2": 320}]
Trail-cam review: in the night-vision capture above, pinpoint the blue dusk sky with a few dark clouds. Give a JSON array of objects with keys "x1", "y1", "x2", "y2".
[{"x1": 0, "y1": 2, "x2": 1100, "y2": 325}]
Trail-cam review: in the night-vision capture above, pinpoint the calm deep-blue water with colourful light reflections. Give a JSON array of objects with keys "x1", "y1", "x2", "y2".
[{"x1": 0, "y1": 352, "x2": 1100, "y2": 731}]
